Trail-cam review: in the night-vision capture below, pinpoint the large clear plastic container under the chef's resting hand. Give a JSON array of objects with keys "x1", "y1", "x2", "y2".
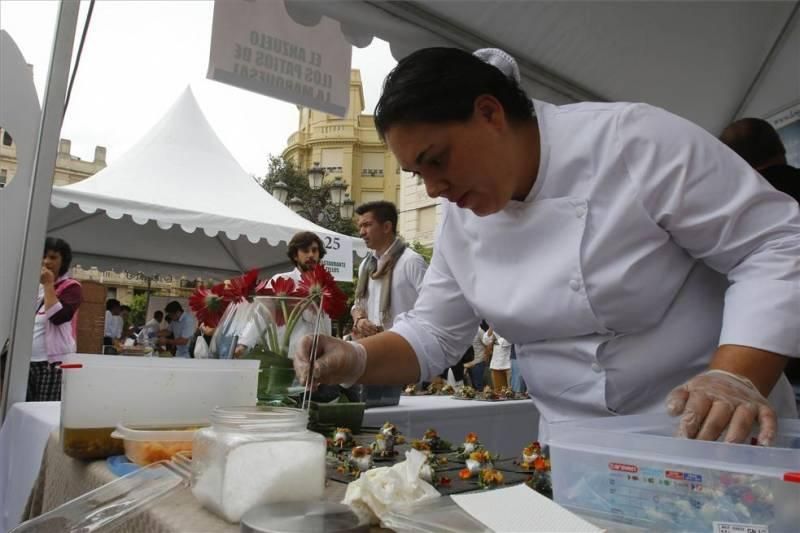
[{"x1": 549, "y1": 415, "x2": 800, "y2": 533}]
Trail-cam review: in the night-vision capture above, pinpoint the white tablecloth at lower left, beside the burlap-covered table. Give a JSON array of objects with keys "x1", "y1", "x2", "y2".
[{"x1": 0, "y1": 402, "x2": 61, "y2": 531}]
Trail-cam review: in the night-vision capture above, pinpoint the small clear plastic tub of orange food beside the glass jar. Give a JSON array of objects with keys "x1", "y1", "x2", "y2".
[{"x1": 111, "y1": 425, "x2": 205, "y2": 466}]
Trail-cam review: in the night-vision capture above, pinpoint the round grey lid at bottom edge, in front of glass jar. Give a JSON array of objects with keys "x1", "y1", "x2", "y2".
[{"x1": 241, "y1": 501, "x2": 369, "y2": 533}]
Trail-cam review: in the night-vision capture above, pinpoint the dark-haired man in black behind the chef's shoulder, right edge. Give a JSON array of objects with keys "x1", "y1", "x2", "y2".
[{"x1": 719, "y1": 118, "x2": 800, "y2": 384}]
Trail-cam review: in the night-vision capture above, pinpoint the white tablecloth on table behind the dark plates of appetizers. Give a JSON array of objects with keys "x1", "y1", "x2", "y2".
[{"x1": 364, "y1": 396, "x2": 539, "y2": 457}]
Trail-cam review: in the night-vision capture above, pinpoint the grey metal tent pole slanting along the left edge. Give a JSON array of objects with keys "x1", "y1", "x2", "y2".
[{"x1": 0, "y1": 0, "x2": 80, "y2": 418}]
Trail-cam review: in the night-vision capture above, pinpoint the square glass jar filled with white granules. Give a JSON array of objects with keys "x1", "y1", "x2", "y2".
[{"x1": 192, "y1": 407, "x2": 326, "y2": 523}]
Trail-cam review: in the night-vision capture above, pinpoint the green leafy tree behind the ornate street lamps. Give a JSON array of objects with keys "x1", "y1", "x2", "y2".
[{"x1": 261, "y1": 154, "x2": 358, "y2": 236}]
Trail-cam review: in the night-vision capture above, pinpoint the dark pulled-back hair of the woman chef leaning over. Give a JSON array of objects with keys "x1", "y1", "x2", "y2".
[{"x1": 375, "y1": 48, "x2": 533, "y2": 139}]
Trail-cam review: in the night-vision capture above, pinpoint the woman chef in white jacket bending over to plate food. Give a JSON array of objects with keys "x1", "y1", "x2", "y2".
[{"x1": 294, "y1": 48, "x2": 800, "y2": 445}]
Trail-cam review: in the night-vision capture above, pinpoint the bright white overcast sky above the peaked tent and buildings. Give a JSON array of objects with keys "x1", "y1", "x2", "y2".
[{"x1": 0, "y1": 0, "x2": 395, "y2": 176}]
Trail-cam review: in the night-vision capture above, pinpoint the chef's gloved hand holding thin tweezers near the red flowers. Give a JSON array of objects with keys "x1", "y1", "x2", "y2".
[{"x1": 294, "y1": 335, "x2": 367, "y2": 390}]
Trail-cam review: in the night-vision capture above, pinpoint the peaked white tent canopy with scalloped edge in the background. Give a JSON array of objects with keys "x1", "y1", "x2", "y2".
[{"x1": 48, "y1": 88, "x2": 366, "y2": 277}]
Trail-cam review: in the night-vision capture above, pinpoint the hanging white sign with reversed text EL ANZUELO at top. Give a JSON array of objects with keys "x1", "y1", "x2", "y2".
[{"x1": 208, "y1": 0, "x2": 351, "y2": 117}]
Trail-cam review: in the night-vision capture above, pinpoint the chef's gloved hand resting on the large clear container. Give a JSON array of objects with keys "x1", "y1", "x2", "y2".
[{"x1": 667, "y1": 370, "x2": 778, "y2": 446}]
